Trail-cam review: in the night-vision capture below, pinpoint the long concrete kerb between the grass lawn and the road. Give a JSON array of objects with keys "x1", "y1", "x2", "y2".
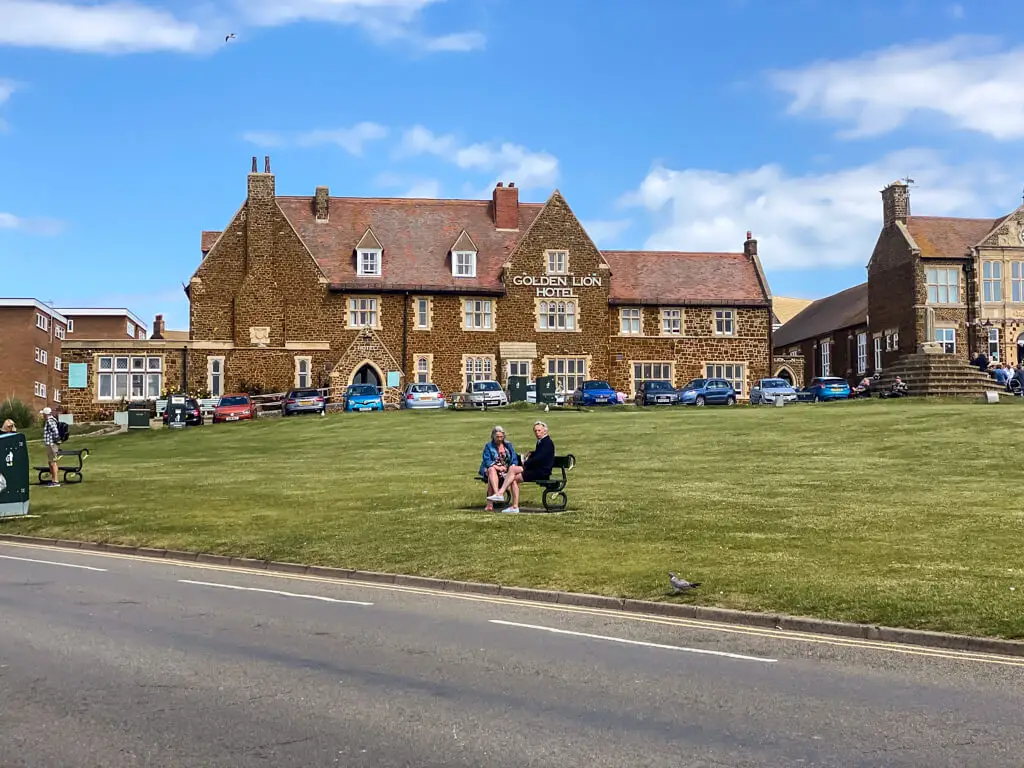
[{"x1": 0, "y1": 534, "x2": 1024, "y2": 657}]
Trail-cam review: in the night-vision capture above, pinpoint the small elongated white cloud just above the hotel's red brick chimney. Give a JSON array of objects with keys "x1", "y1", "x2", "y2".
[{"x1": 395, "y1": 125, "x2": 559, "y2": 194}]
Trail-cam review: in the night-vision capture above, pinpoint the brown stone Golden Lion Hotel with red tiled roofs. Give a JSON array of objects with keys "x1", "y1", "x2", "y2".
[{"x1": 59, "y1": 158, "x2": 772, "y2": 412}]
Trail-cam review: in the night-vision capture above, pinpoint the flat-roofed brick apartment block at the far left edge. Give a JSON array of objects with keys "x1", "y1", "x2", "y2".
[{"x1": 0, "y1": 299, "x2": 68, "y2": 410}]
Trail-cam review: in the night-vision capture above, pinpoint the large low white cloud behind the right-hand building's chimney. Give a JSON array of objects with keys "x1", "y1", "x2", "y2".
[{"x1": 622, "y1": 150, "x2": 1011, "y2": 269}]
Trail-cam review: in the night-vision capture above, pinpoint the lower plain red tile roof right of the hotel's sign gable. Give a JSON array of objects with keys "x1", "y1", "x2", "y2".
[{"x1": 601, "y1": 251, "x2": 769, "y2": 306}]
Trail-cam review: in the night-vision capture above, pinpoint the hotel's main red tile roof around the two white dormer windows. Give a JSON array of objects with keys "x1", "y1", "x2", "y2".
[{"x1": 278, "y1": 197, "x2": 544, "y2": 293}]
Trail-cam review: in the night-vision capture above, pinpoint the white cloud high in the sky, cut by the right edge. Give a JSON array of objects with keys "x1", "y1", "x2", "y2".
[{"x1": 769, "y1": 37, "x2": 1024, "y2": 140}]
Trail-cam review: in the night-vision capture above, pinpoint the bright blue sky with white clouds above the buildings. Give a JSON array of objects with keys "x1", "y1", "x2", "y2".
[{"x1": 0, "y1": 0, "x2": 1024, "y2": 328}]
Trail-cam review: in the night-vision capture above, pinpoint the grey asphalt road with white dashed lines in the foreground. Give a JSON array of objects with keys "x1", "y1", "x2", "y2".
[{"x1": 0, "y1": 544, "x2": 1024, "y2": 768}]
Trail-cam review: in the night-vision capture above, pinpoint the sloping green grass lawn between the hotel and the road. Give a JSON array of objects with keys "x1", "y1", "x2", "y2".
[{"x1": 0, "y1": 400, "x2": 1024, "y2": 637}]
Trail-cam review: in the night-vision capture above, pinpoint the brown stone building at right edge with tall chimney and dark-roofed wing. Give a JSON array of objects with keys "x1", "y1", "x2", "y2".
[{"x1": 775, "y1": 181, "x2": 1024, "y2": 385}]
